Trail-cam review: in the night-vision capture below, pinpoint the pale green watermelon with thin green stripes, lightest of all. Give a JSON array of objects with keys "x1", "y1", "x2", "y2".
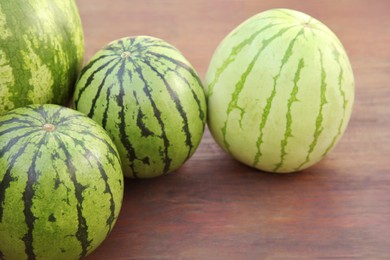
[{"x1": 205, "y1": 9, "x2": 354, "y2": 173}]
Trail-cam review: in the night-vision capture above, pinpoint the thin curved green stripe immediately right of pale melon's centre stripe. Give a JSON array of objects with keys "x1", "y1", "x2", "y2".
[{"x1": 295, "y1": 50, "x2": 327, "y2": 171}]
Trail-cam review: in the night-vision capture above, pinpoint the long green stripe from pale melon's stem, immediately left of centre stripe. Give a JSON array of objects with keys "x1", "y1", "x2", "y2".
[{"x1": 253, "y1": 28, "x2": 303, "y2": 166}]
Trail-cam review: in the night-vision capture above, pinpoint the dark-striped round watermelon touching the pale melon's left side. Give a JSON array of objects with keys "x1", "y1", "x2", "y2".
[{"x1": 73, "y1": 36, "x2": 206, "y2": 178}]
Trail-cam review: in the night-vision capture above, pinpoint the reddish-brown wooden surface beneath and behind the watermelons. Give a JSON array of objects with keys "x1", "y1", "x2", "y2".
[{"x1": 77, "y1": 0, "x2": 390, "y2": 259}]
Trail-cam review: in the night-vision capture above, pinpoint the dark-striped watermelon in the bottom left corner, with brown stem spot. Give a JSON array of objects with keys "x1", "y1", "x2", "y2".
[{"x1": 0, "y1": 105, "x2": 124, "y2": 260}]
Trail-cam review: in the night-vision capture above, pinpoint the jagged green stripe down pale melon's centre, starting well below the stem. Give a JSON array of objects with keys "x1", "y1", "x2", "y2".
[{"x1": 273, "y1": 58, "x2": 305, "y2": 172}]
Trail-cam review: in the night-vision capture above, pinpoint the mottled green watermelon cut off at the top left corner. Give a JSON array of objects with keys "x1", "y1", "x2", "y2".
[{"x1": 0, "y1": 0, "x2": 84, "y2": 114}]
